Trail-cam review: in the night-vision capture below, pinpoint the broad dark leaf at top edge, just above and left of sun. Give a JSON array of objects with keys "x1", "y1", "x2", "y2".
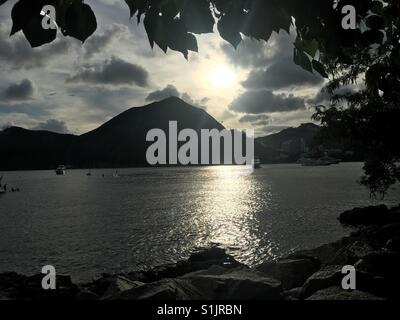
[{"x1": 181, "y1": 0, "x2": 215, "y2": 34}]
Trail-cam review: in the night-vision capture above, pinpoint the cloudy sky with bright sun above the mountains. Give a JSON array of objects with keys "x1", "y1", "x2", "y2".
[{"x1": 0, "y1": 0, "x2": 332, "y2": 136}]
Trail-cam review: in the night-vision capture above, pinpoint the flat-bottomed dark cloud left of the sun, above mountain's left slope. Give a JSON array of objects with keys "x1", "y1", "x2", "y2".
[{"x1": 67, "y1": 57, "x2": 149, "y2": 87}]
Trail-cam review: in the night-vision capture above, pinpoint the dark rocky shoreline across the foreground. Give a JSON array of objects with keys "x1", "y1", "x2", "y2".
[{"x1": 0, "y1": 205, "x2": 400, "y2": 301}]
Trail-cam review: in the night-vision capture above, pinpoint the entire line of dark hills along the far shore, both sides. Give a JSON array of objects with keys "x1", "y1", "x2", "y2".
[{"x1": 0, "y1": 97, "x2": 356, "y2": 170}]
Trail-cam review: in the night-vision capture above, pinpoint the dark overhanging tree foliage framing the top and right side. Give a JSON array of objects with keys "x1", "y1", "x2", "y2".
[{"x1": 0, "y1": 0, "x2": 400, "y2": 195}]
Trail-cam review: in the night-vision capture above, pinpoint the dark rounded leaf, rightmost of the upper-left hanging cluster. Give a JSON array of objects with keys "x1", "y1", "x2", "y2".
[{"x1": 65, "y1": 2, "x2": 97, "y2": 42}]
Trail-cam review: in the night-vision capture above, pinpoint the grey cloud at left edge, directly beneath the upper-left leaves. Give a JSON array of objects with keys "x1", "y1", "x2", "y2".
[{"x1": 0, "y1": 24, "x2": 71, "y2": 69}]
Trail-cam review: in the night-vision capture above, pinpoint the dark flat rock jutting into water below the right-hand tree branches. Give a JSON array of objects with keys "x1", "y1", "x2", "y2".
[{"x1": 339, "y1": 205, "x2": 391, "y2": 226}]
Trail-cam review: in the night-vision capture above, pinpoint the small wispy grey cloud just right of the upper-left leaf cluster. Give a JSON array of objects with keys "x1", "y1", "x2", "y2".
[{"x1": 84, "y1": 24, "x2": 128, "y2": 58}]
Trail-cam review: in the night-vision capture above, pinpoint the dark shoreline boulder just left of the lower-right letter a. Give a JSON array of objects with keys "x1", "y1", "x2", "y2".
[{"x1": 257, "y1": 258, "x2": 320, "y2": 290}]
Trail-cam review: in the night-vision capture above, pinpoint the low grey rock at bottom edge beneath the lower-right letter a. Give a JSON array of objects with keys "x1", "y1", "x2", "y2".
[{"x1": 307, "y1": 287, "x2": 384, "y2": 301}]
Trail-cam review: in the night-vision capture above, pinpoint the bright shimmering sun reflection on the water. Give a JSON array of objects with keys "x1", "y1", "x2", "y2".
[{"x1": 191, "y1": 166, "x2": 276, "y2": 262}]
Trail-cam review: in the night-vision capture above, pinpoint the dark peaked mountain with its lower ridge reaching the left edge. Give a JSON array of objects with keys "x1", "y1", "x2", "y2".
[{"x1": 0, "y1": 97, "x2": 224, "y2": 170}]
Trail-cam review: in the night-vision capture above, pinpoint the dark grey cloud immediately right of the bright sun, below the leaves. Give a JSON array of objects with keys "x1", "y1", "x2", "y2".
[{"x1": 242, "y1": 58, "x2": 324, "y2": 90}]
